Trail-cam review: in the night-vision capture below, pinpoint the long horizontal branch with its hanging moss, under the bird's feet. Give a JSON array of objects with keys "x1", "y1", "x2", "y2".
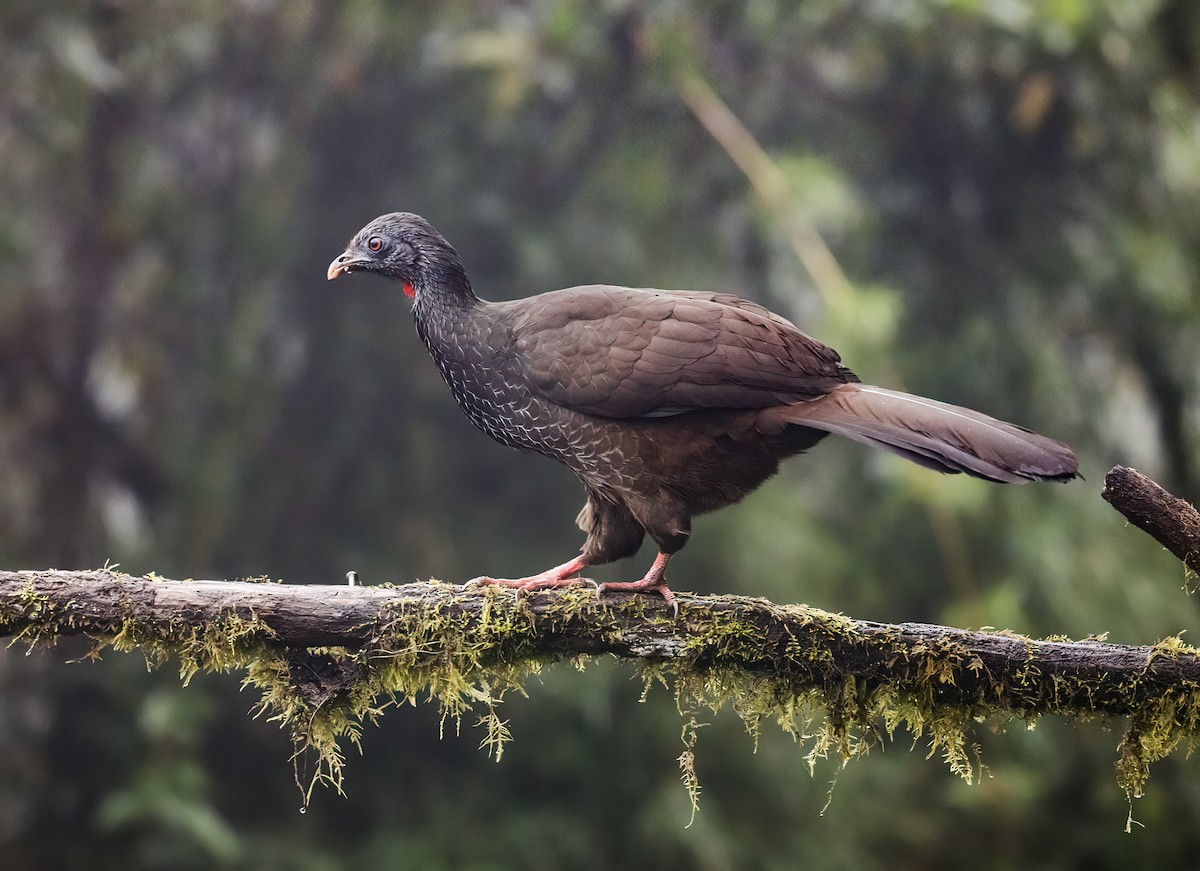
[{"x1": 0, "y1": 571, "x2": 1200, "y2": 811}]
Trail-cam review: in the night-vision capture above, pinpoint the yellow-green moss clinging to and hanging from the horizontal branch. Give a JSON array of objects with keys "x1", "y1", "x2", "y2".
[{"x1": 0, "y1": 582, "x2": 1200, "y2": 804}]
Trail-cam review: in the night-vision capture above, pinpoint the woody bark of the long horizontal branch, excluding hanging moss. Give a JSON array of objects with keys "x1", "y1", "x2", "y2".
[{"x1": 0, "y1": 571, "x2": 1200, "y2": 715}]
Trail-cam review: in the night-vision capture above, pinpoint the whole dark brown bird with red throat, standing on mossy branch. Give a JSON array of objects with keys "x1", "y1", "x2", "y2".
[{"x1": 329, "y1": 212, "x2": 1078, "y2": 608}]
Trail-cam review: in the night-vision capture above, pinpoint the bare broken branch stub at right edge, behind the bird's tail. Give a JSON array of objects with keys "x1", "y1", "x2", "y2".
[{"x1": 1100, "y1": 465, "x2": 1200, "y2": 573}]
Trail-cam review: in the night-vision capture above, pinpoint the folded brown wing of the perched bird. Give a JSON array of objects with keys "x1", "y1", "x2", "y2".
[{"x1": 510, "y1": 286, "x2": 858, "y2": 418}]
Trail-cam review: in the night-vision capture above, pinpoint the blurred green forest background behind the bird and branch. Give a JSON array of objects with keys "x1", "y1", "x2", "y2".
[{"x1": 0, "y1": 0, "x2": 1200, "y2": 870}]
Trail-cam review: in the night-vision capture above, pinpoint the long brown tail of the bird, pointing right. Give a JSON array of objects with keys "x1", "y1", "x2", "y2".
[{"x1": 786, "y1": 384, "x2": 1079, "y2": 483}]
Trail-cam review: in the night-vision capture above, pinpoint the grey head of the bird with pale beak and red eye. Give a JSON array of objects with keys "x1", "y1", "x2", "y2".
[{"x1": 326, "y1": 211, "x2": 473, "y2": 305}]
